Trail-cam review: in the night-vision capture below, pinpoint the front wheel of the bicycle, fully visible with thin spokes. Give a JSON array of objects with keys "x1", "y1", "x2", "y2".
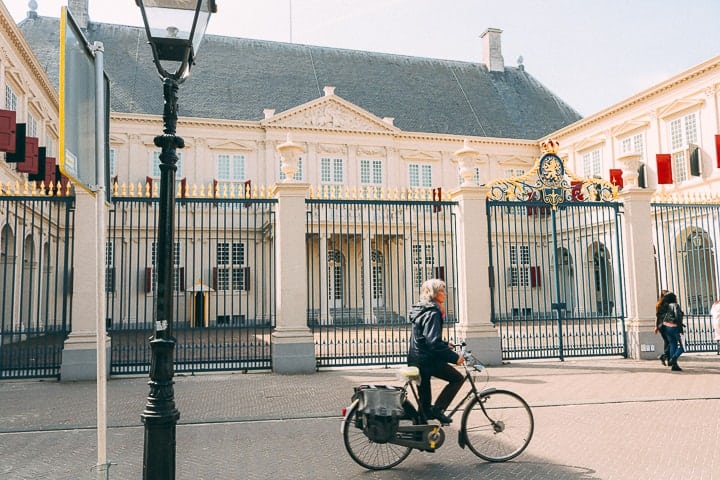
[{"x1": 461, "y1": 390, "x2": 535, "y2": 462}]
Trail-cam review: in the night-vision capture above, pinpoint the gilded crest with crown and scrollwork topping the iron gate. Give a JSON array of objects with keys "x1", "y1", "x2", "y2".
[{"x1": 487, "y1": 140, "x2": 618, "y2": 210}]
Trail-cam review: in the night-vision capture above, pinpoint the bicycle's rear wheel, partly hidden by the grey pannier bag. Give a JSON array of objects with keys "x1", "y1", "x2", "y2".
[{"x1": 342, "y1": 403, "x2": 412, "y2": 470}]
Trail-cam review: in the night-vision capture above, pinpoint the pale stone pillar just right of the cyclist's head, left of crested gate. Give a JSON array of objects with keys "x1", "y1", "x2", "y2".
[{"x1": 452, "y1": 186, "x2": 502, "y2": 365}]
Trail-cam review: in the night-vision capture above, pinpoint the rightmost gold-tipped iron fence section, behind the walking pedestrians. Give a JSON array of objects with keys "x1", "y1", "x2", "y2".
[{"x1": 651, "y1": 195, "x2": 720, "y2": 352}]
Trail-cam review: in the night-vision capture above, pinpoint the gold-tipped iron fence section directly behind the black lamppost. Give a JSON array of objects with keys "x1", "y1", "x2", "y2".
[{"x1": 106, "y1": 187, "x2": 276, "y2": 374}]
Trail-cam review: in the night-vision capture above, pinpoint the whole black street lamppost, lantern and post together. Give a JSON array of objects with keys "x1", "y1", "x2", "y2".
[{"x1": 135, "y1": 0, "x2": 217, "y2": 480}]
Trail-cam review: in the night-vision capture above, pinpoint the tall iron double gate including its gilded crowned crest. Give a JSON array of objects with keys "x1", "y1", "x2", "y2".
[{"x1": 487, "y1": 153, "x2": 627, "y2": 359}]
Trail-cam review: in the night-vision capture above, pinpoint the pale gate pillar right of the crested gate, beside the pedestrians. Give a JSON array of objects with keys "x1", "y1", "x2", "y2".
[{"x1": 620, "y1": 186, "x2": 663, "y2": 360}]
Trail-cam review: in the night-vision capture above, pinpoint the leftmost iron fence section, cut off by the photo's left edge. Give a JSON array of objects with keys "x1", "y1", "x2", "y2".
[{"x1": 0, "y1": 185, "x2": 75, "y2": 378}]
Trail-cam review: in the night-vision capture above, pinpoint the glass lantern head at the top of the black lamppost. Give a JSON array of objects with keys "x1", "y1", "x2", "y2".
[{"x1": 135, "y1": 0, "x2": 217, "y2": 82}]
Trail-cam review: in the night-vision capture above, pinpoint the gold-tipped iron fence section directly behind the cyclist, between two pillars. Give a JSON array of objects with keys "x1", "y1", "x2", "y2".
[{"x1": 306, "y1": 190, "x2": 458, "y2": 367}]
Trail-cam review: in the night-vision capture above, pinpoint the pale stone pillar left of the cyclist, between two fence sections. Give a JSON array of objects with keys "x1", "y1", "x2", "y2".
[{"x1": 272, "y1": 183, "x2": 316, "y2": 373}]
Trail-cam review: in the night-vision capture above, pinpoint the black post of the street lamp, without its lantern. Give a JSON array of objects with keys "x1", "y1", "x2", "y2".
[{"x1": 141, "y1": 78, "x2": 180, "y2": 480}]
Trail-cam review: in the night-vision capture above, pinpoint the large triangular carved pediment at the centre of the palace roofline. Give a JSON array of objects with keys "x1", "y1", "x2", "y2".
[{"x1": 261, "y1": 95, "x2": 399, "y2": 133}]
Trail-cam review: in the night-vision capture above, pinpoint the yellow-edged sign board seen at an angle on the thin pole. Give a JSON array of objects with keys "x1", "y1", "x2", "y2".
[{"x1": 58, "y1": 7, "x2": 109, "y2": 194}]
